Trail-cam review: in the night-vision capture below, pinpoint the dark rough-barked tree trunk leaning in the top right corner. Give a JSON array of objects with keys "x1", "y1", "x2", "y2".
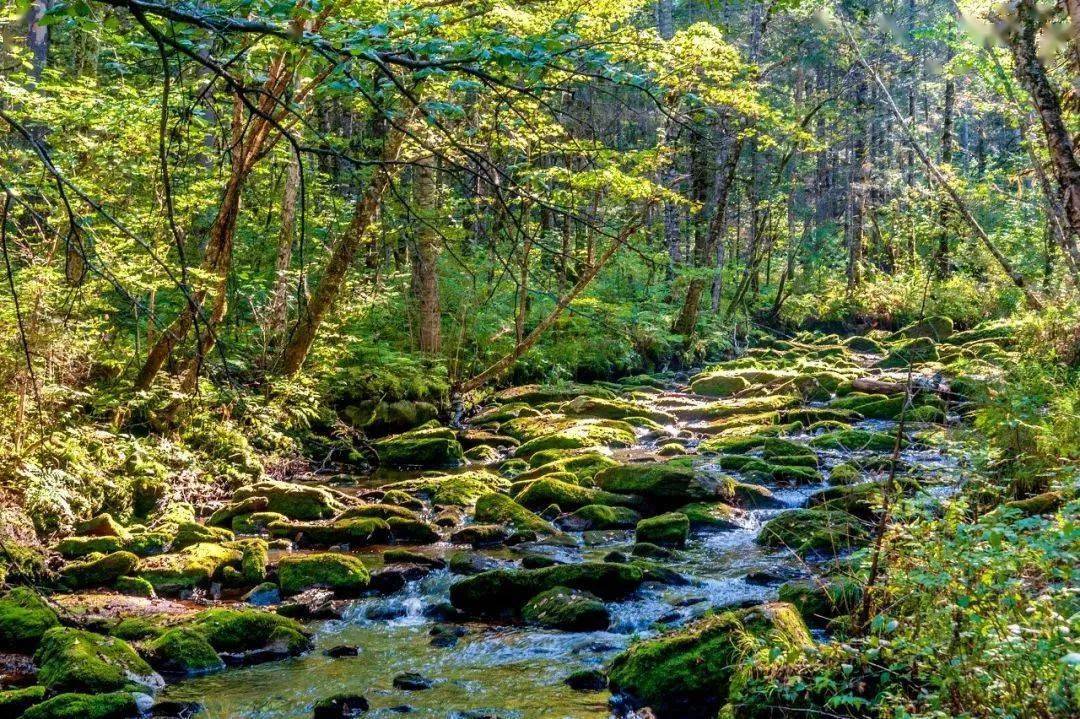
[{"x1": 1003, "y1": 0, "x2": 1080, "y2": 274}]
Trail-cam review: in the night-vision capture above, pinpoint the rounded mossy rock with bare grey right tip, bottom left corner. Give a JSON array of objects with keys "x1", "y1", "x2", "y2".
[{"x1": 33, "y1": 626, "x2": 164, "y2": 693}]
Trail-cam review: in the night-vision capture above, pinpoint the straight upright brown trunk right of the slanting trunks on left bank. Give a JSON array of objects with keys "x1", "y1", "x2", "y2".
[{"x1": 413, "y1": 158, "x2": 443, "y2": 354}]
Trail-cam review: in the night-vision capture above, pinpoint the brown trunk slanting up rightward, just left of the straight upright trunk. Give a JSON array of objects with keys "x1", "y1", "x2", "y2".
[{"x1": 282, "y1": 118, "x2": 405, "y2": 376}]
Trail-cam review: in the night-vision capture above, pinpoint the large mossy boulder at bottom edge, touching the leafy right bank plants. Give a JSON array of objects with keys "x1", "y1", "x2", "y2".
[{"x1": 608, "y1": 602, "x2": 813, "y2": 718}]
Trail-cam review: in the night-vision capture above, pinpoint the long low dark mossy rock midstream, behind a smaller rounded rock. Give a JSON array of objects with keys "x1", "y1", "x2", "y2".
[{"x1": 450, "y1": 561, "x2": 643, "y2": 615}]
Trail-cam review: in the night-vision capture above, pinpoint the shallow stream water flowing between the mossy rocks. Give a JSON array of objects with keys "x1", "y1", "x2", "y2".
[{"x1": 163, "y1": 375, "x2": 956, "y2": 719}]
